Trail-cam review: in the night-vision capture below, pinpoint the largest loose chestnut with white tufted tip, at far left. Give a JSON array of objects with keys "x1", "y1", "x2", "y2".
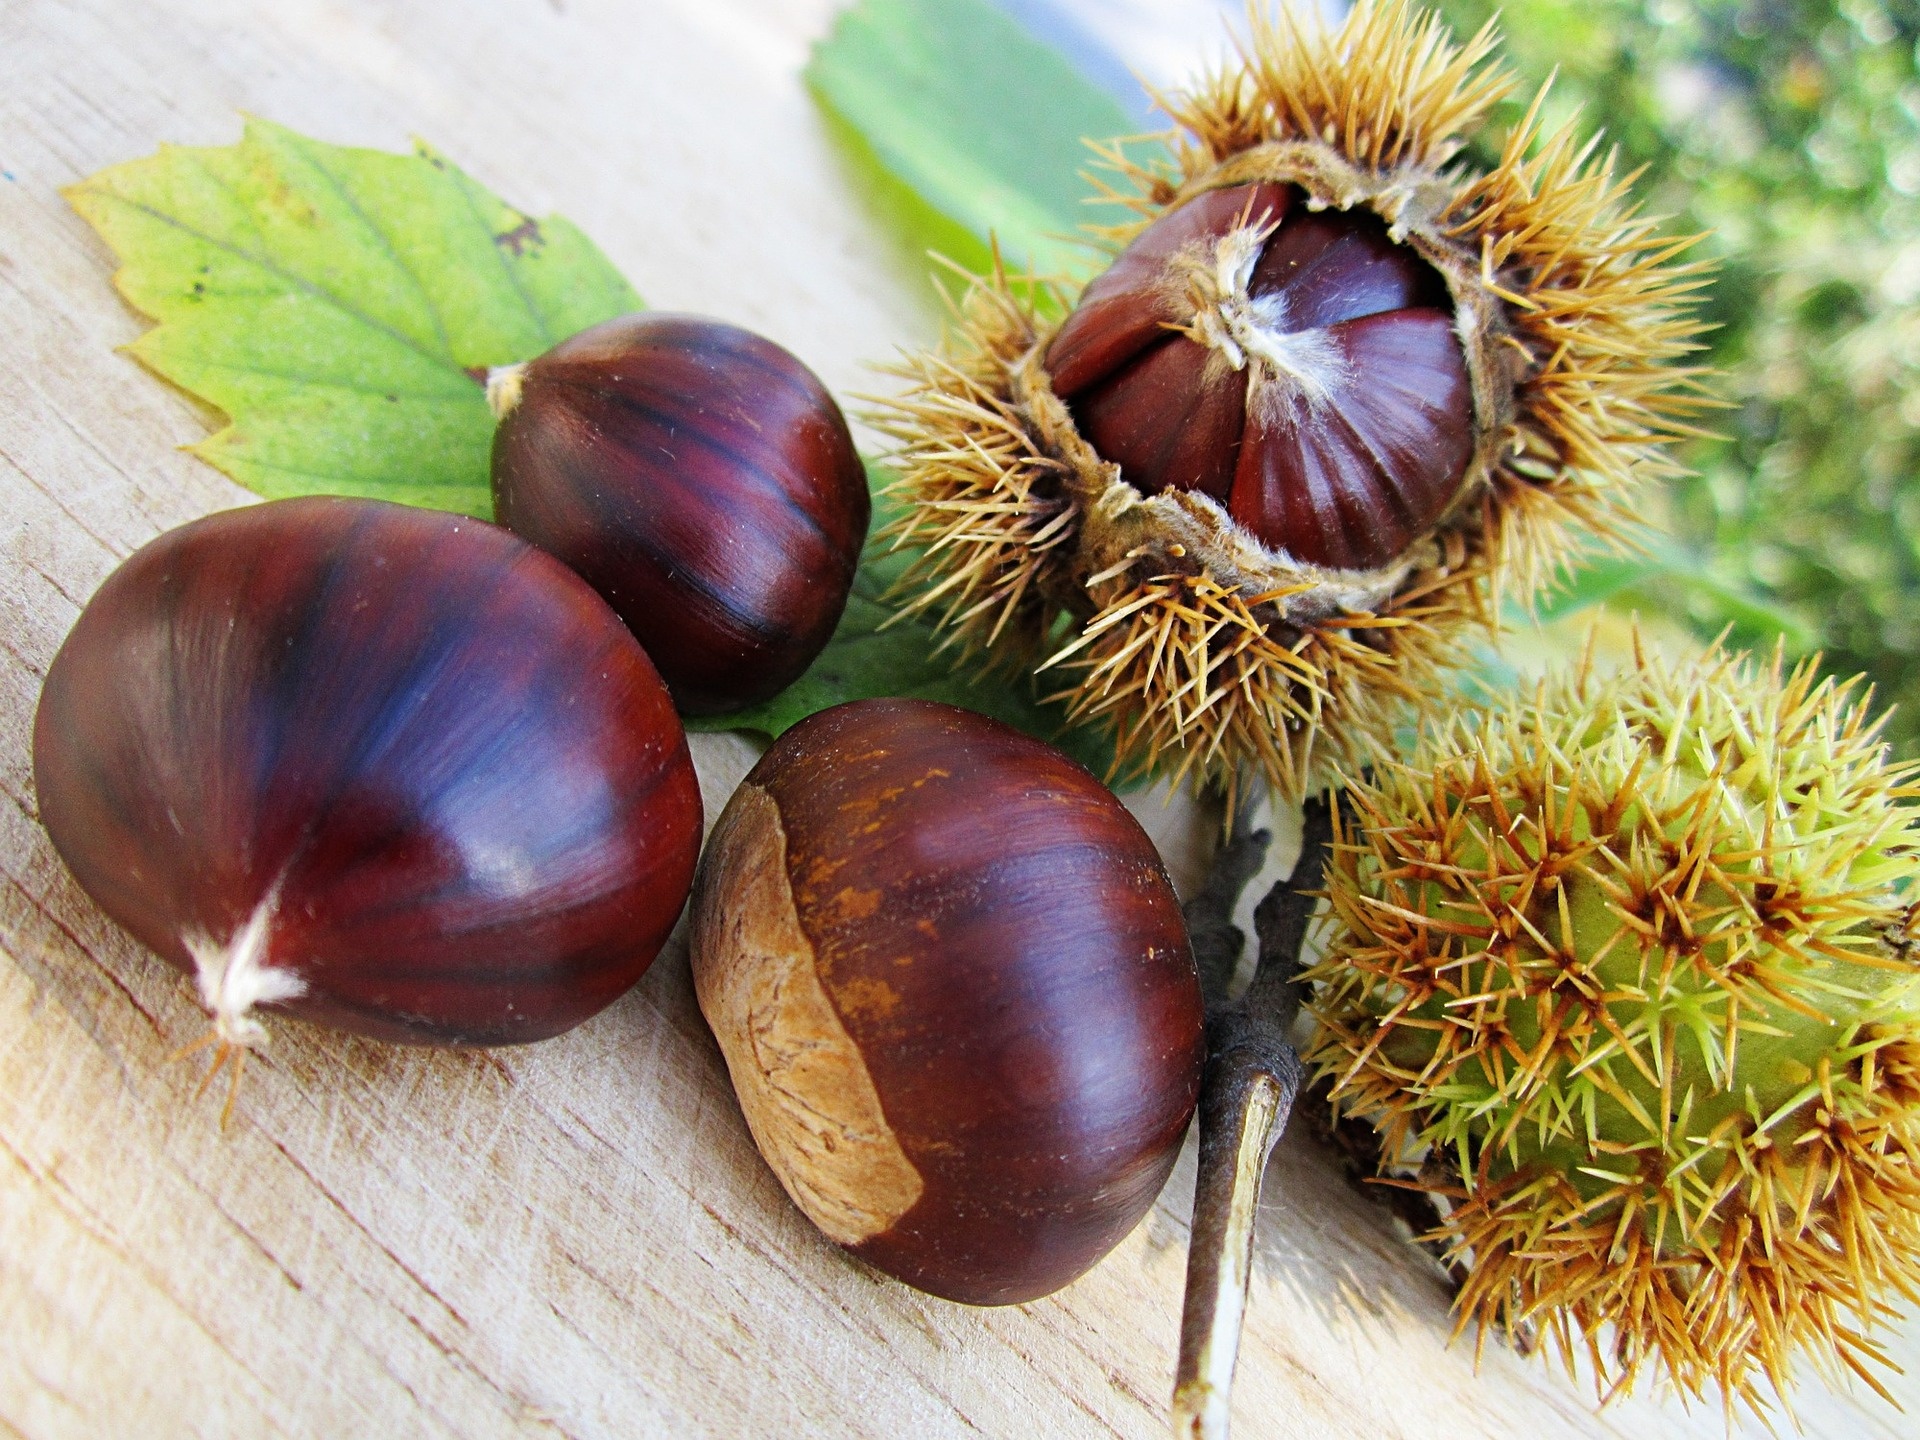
[{"x1": 33, "y1": 499, "x2": 701, "y2": 1046}]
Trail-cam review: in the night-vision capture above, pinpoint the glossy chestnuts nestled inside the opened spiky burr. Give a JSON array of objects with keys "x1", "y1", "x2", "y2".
[{"x1": 1046, "y1": 184, "x2": 1475, "y2": 570}]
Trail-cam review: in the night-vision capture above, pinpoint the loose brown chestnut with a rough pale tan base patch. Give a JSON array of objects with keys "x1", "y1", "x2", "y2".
[{"x1": 691, "y1": 701, "x2": 1202, "y2": 1306}]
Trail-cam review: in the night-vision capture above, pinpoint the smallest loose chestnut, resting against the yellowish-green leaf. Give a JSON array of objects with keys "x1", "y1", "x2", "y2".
[{"x1": 488, "y1": 313, "x2": 870, "y2": 714}]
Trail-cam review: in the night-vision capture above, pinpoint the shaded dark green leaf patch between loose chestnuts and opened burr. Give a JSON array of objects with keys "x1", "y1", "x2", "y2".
[{"x1": 687, "y1": 470, "x2": 1114, "y2": 776}]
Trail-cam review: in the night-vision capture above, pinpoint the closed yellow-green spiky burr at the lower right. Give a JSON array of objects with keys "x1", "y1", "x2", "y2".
[{"x1": 1306, "y1": 637, "x2": 1920, "y2": 1409}]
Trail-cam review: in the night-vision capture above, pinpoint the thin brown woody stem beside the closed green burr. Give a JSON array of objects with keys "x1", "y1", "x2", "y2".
[{"x1": 1173, "y1": 799, "x2": 1332, "y2": 1440}]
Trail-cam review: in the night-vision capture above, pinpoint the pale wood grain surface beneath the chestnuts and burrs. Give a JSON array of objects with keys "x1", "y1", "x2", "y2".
[{"x1": 0, "y1": 0, "x2": 1920, "y2": 1440}]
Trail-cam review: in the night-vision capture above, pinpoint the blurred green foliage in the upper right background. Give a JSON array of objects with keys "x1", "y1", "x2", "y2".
[{"x1": 1440, "y1": 0, "x2": 1920, "y2": 755}]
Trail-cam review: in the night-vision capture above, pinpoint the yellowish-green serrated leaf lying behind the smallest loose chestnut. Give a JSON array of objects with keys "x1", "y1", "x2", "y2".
[{"x1": 67, "y1": 119, "x2": 639, "y2": 516}]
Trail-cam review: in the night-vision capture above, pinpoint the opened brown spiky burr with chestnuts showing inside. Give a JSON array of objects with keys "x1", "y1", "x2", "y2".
[{"x1": 879, "y1": 0, "x2": 1701, "y2": 797}]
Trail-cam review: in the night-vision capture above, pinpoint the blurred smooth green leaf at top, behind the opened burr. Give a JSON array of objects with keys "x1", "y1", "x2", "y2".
[{"x1": 806, "y1": 0, "x2": 1135, "y2": 275}]
